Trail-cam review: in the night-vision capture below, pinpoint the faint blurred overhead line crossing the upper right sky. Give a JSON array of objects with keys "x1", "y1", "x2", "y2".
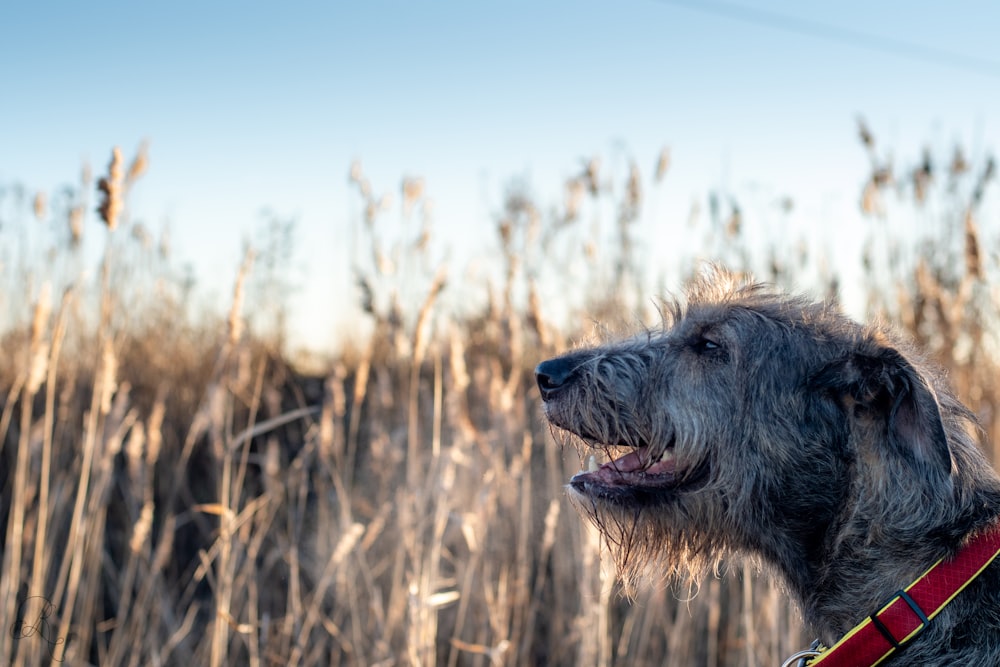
[{"x1": 657, "y1": 0, "x2": 1000, "y2": 78}]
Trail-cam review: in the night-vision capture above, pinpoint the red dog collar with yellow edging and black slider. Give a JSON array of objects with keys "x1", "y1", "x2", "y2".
[{"x1": 785, "y1": 526, "x2": 1000, "y2": 667}]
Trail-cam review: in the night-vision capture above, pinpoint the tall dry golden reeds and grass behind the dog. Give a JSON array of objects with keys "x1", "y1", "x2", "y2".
[{"x1": 0, "y1": 128, "x2": 1000, "y2": 666}]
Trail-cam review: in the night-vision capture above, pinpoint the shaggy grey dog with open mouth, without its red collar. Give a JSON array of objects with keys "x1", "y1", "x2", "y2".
[{"x1": 536, "y1": 270, "x2": 1000, "y2": 666}]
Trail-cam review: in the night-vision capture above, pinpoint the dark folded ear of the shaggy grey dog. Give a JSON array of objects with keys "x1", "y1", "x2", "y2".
[{"x1": 815, "y1": 345, "x2": 952, "y2": 476}]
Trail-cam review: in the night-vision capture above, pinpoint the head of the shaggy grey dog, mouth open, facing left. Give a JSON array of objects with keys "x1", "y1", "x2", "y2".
[{"x1": 536, "y1": 275, "x2": 982, "y2": 596}]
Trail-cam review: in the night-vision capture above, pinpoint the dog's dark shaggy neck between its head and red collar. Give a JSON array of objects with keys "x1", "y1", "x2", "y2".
[{"x1": 762, "y1": 422, "x2": 1000, "y2": 641}]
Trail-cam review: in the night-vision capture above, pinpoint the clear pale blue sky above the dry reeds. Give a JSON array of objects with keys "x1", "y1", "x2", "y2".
[{"x1": 0, "y1": 0, "x2": 1000, "y2": 347}]
